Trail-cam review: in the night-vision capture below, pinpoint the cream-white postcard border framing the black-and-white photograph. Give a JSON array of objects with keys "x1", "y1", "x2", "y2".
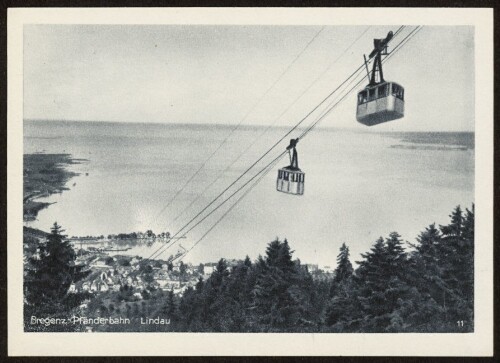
[{"x1": 7, "y1": 8, "x2": 493, "y2": 356}]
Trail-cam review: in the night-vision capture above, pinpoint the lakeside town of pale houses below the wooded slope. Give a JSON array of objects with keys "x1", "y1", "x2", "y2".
[{"x1": 24, "y1": 226, "x2": 334, "y2": 331}]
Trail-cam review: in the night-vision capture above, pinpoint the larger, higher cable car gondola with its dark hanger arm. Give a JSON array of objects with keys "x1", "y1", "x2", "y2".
[{"x1": 356, "y1": 32, "x2": 404, "y2": 126}]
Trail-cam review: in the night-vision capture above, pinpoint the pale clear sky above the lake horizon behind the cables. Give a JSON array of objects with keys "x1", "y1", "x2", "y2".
[{"x1": 24, "y1": 25, "x2": 475, "y2": 131}]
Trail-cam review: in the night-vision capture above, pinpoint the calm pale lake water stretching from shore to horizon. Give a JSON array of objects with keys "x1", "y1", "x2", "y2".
[{"x1": 24, "y1": 121, "x2": 474, "y2": 266}]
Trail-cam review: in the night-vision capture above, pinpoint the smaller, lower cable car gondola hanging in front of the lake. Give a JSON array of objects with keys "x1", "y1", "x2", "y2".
[{"x1": 276, "y1": 138, "x2": 305, "y2": 195}]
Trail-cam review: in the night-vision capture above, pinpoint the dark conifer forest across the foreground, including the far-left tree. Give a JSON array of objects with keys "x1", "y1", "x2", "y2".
[{"x1": 25, "y1": 205, "x2": 474, "y2": 333}]
